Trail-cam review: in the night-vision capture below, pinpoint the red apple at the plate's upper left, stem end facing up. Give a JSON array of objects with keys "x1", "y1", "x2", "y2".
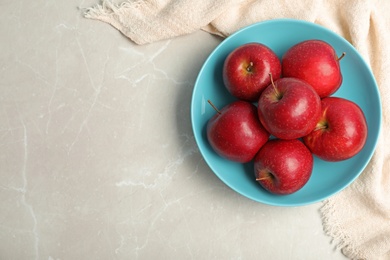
[{"x1": 223, "y1": 43, "x2": 282, "y2": 102}]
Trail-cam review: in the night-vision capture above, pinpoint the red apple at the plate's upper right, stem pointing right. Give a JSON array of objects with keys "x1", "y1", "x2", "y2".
[{"x1": 282, "y1": 40, "x2": 343, "y2": 98}]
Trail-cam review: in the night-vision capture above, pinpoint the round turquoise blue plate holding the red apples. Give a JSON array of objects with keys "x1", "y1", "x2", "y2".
[{"x1": 191, "y1": 19, "x2": 381, "y2": 206}]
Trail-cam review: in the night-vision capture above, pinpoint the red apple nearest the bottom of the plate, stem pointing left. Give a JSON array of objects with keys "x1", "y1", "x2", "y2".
[{"x1": 254, "y1": 139, "x2": 314, "y2": 195}]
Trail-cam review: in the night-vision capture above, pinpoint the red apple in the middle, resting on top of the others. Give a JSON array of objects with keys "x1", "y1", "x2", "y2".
[{"x1": 258, "y1": 78, "x2": 321, "y2": 139}]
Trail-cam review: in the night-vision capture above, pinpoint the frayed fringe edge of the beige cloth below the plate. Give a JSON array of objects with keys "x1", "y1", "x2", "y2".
[{"x1": 320, "y1": 200, "x2": 365, "y2": 259}]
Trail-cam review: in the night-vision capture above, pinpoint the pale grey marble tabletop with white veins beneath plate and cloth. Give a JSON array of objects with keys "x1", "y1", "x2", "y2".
[{"x1": 0, "y1": 0, "x2": 343, "y2": 260}]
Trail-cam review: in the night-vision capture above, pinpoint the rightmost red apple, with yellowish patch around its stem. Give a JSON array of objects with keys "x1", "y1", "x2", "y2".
[{"x1": 303, "y1": 97, "x2": 368, "y2": 161}]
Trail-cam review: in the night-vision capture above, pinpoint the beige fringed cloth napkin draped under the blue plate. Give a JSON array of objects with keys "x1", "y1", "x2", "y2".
[{"x1": 85, "y1": 0, "x2": 390, "y2": 259}]
